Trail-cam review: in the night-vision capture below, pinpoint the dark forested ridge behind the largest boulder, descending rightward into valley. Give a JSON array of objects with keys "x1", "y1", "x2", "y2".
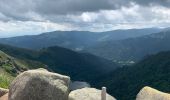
[{"x1": 0, "y1": 45, "x2": 119, "y2": 82}]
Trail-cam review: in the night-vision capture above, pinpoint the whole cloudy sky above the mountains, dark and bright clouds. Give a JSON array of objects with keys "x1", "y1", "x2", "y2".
[{"x1": 0, "y1": 0, "x2": 170, "y2": 37}]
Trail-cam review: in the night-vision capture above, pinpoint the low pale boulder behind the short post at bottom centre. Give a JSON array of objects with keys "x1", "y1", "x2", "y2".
[{"x1": 69, "y1": 88, "x2": 116, "y2": 100}]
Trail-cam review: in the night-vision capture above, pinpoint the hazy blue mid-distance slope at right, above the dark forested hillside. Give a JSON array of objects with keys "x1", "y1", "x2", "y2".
[{"x1": 86, "y1": 31, "x2": 170, "y2": 61}]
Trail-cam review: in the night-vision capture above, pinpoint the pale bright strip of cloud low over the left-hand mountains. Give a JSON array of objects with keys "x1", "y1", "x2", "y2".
[{"x1": 0, "y1": 21, "x2": 74, "y2": 38}]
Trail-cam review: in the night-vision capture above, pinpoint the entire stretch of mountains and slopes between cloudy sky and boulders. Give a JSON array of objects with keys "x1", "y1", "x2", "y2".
[{"x1": 0, "y1": 29, "x2": 170, "y2": 100}]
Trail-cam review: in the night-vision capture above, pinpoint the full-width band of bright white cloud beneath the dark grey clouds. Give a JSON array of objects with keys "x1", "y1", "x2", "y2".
[{"x1": 0, "y1": 3, "x2": 170, "y2": 37}]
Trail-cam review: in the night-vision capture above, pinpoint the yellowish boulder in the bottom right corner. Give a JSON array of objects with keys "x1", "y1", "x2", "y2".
[{"x1": 136, "y1": 86, "x2": 170, "y2": 100}]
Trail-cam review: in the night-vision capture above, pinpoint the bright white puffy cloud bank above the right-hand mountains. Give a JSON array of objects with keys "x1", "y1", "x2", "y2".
[{"x1": 64, "y1": 4, "x2": 170, "y2": 31}]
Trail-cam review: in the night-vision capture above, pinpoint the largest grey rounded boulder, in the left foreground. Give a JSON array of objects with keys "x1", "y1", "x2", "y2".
[{"x1": 9, "y1": 69, "x2": 70, "y2": 100}]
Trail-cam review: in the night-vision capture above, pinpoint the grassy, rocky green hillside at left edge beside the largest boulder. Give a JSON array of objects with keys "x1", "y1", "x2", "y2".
[{"x1": 0, "y1": 51, "x2": 45, "y2": 88}]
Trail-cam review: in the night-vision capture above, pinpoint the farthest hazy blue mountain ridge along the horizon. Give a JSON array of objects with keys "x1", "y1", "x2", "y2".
[{"x1": 0, "y1": 28, "x2": 162, "y2": 50}]
